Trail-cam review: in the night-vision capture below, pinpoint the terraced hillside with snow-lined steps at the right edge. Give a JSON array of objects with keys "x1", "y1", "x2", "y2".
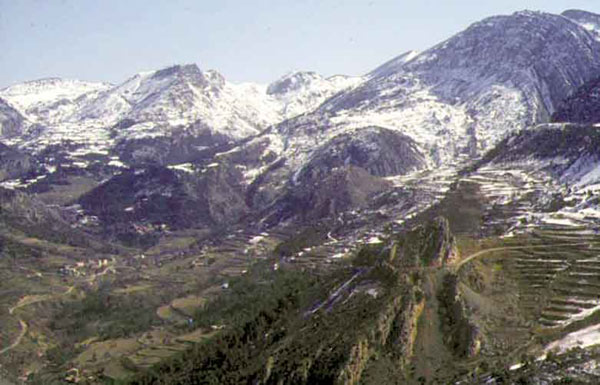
[{"x1": 452, "y1": 164, "x2": 600, "y2": 355}]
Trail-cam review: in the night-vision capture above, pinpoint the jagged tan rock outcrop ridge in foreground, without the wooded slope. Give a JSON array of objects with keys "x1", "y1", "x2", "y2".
[{"x1": 260, "y1": 218, "x2": 460, "y2": 385}]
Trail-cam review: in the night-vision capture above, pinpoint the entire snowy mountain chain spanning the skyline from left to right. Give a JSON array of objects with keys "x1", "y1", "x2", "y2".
[{"x1": 0, "y1": 11, "x2": 600, "y2": 228}]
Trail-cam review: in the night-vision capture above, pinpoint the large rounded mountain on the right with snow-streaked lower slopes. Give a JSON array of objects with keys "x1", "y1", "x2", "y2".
[{"x1": 186, "y1": 11, "x2": 600, "y2": 228}]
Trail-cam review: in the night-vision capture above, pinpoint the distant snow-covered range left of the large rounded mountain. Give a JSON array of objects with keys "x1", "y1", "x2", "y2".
[{"x1": 0, "y1": 64, "x2": 362, "y2": 164}]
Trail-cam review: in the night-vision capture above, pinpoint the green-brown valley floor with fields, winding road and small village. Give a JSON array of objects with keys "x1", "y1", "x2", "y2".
[{"x1": 0, "y1": 207, "x2": 292, "y2": 384}]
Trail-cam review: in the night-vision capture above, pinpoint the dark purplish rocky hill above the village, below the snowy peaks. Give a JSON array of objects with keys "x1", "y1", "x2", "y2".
[{"x1": 79, "y1": 166, "x2": 247, "y2": 242}]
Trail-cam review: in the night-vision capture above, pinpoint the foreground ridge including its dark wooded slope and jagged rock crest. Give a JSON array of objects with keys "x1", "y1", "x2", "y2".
[{"x1": 122, "y1": 218, "x2": 455, "y2": 385}]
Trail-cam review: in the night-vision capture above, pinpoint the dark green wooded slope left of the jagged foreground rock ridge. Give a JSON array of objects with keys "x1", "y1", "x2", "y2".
[{"x1": 124, "y1": 269, "x2": 320, "y2": 384}]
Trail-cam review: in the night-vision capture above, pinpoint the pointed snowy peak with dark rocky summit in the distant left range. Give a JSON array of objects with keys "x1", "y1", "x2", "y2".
[{"x1": 71, "y1": 64, "x2": 278, "y2": 143}]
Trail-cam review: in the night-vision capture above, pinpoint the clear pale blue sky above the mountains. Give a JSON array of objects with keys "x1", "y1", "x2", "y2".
[{"x1": 0, "y1": 0, "x2": 600, "y2": 88}]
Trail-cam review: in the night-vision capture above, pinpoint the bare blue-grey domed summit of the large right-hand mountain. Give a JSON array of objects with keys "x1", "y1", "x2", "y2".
[{"x1": 407, "y1": 11, "x2": 600, "y2": 112}]
